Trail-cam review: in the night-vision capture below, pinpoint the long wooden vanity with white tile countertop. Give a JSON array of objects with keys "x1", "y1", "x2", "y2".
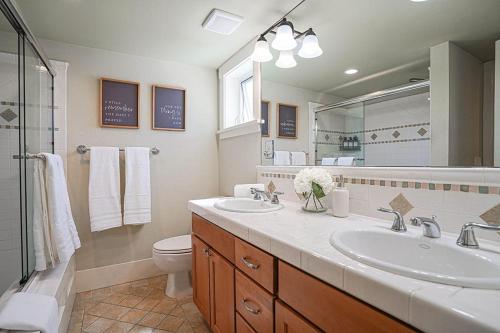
[{"x1": 189, "y1": 199, "x2": 500, "y2": 332}]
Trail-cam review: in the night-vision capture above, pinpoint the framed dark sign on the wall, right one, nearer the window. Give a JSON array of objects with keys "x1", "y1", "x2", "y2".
[{"x1": 151, "y1": 85, "x2": 187, "y2": 131}]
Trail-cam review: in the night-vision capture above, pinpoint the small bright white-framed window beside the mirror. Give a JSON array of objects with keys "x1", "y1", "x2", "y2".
[{"x1": 222, "y1": 59, "x2": 255, "y2": 129}]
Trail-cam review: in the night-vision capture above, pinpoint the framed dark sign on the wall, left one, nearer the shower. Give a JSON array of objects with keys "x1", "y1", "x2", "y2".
[{"x1": 99, "y1": 77, "x2": 140, "y2": 129}]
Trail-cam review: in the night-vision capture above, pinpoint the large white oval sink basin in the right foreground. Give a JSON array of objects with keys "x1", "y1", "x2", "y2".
[{"x1": 330, "y1": 227, "x2": 500, "y2": 289}]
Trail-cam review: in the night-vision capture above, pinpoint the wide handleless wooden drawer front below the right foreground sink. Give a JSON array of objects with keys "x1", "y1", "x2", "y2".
[{"x1": 278, "y1": 261, "x2": 416, "y2": 333}]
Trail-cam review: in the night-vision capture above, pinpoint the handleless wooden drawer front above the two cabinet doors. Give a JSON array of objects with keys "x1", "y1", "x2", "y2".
[{"x1": 193, "y1": 214, "x2": 234, "y2": 264}]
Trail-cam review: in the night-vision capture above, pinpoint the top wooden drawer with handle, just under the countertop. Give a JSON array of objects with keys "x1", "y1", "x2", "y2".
[{"x1": 234, "y1": 238, "x2": 276, "y2": 293}]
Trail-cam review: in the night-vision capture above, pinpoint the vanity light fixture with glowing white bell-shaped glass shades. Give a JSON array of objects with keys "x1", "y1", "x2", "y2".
[{"x1": 251, "y1": 0, "x2": 323, "y2": 68}]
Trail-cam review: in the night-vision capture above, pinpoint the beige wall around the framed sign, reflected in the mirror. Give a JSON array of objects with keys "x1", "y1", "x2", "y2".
[{"x1": 262, "y1": 80, "x2": 341, "y2": 165}]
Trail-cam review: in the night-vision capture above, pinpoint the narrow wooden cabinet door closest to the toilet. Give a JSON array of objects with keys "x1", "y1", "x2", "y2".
[{"x1": 191, "y1": 235, "x2": 210, "y2": 323}]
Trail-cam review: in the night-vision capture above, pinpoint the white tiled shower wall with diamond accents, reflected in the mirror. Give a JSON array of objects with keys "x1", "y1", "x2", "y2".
[{"x1": 365, "y1": 93, "x2": 431, "y2": 166}]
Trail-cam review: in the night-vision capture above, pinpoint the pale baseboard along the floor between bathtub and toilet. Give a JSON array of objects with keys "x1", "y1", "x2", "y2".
[{"x1": 76, "y1": 258, "x2": 164, "y2": 292}]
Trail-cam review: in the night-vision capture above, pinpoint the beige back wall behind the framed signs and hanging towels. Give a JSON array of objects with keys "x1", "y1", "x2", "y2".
[{"x1": 41, "y1": 40, "x2": 218, "y2": 270}]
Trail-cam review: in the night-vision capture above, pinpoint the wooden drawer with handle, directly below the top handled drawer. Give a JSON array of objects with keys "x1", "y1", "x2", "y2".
[{"x1": 235, "y1": 271, "x2": 273, "y2": 333}]
